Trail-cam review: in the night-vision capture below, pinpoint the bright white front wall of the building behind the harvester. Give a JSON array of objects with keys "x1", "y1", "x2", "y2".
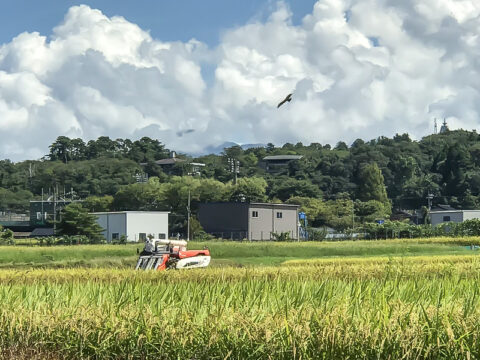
[{"x1": 127, "y1": 211, "x2": 168, "y2": 241}]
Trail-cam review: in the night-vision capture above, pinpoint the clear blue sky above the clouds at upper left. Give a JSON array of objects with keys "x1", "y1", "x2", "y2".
[{"x1": 0, "y1": 0, "x2": 315, "y2": 46}]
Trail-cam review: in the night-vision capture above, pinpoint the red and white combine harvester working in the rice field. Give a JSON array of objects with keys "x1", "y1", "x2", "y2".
[{"x1": 135, "y1": 239, "x2": 210, "y2": 270}]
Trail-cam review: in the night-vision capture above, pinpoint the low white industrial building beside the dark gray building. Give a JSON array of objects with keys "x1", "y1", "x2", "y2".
[{"x1": 92, "y1": 211, "x2": 169, "y2": 242}]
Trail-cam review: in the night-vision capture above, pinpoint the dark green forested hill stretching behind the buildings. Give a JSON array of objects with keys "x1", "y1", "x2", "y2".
[{"x1": 0, "y1": 130, "x2": 480, "y2": 219}]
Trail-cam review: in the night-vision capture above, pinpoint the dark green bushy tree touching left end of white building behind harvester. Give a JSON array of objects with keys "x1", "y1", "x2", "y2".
[{"x1": 58, "y1": 203, "x2": 104, "y2": 243}]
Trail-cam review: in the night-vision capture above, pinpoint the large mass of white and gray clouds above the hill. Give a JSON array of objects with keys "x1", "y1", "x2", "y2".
[{"x1": 0, "y1": 0, "x2": 480, "y2": 160}]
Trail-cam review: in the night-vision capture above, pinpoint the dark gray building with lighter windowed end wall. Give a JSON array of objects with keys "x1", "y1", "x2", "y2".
[{"x1": 198, "y1": 202, "x2": 299, "y2": 240}]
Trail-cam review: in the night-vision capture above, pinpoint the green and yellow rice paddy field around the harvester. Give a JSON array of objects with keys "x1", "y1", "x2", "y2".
[{"x1": 0, "y1": 238, "x2": 480, "y2": 359}]
